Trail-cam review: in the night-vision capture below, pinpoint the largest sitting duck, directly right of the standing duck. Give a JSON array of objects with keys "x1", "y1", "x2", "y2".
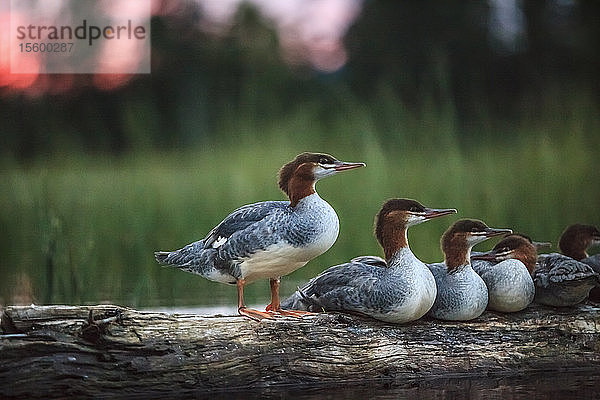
[{"x1": 283, "y1": 199, "x2": 456, "y2": 323}]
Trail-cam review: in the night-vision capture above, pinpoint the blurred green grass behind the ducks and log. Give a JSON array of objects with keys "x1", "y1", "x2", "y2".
[{"x1": 0, "y1": 105, "x2": 600, "y2": 306}]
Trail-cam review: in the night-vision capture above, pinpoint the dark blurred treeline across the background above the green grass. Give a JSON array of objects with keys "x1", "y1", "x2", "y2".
[{"x1": 0, "y1": 0, "x2": 600, "y2": 158}]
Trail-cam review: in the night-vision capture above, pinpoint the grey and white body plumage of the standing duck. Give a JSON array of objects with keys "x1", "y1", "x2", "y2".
[{"x1": 156, "y1": 193, "x2": 339, "y2": 284}]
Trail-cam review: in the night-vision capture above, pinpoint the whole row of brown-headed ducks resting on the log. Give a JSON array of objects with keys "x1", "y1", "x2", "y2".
[{"x1": 155, "y1": 153, "x2": 600, "y2": 323}]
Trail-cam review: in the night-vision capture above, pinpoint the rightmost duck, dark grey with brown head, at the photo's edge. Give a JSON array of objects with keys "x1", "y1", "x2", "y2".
[{"x1": 534, "y1": 224, "x2": 600, "y2": 307}]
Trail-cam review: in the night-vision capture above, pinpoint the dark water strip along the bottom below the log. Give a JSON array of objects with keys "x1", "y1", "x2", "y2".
[{"x1": 184, "y1": 371, "x2": 600, "y2": 400}]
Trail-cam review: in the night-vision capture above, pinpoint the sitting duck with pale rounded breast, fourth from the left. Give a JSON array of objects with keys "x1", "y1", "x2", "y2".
[{"x1": 471, "y1": 235, "x2": 537, "y2": 312}]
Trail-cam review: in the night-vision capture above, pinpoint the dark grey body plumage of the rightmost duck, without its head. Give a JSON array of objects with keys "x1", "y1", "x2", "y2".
[{"x1": 533, "y1": 253, "x2": 600, "y2": 307}]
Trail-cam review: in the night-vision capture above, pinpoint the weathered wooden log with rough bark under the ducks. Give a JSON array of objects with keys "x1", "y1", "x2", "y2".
[{"x1": 0, "y1": 304, "x2": 600, "y2": 398}]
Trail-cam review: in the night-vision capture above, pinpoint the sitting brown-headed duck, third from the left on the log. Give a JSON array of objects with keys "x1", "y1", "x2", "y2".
[{"x1": 428, "y1": 219, "x2": 512, "y2": 321}]
